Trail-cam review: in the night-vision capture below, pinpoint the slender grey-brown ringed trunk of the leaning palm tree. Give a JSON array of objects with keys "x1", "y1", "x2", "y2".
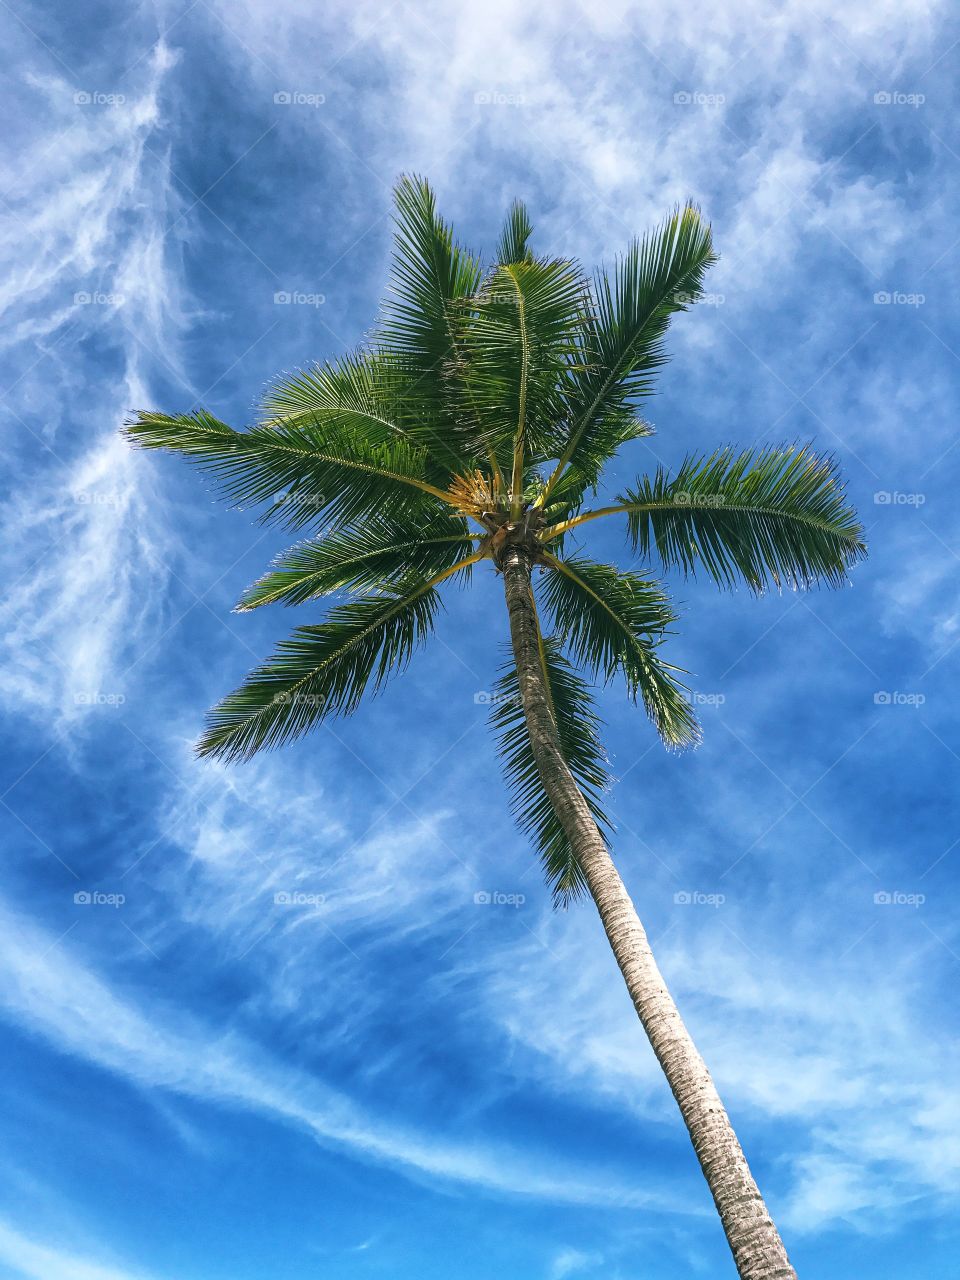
[{"x1": 499, "y1": 547, "x2": 796, "y2": 1280}]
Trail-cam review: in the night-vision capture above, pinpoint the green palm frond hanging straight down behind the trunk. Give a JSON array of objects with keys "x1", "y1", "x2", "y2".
[{"x1": 490, "y1": 637, "x2": 612, "y2": 904}]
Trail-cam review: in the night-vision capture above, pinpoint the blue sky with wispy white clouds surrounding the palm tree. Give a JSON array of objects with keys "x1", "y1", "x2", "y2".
[{"x1": 0, "y1": 0, "x2": 960, "y2": 1280}]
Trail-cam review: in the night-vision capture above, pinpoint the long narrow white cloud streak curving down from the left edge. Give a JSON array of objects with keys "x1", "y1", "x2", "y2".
[{"x1": 0, "y1": 908, "x2": 690, "y2": 1212}]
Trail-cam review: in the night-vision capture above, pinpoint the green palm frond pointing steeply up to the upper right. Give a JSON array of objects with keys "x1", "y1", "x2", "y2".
[{"x1": 548, "y1": 205, "x2": 716, "y2": 492}]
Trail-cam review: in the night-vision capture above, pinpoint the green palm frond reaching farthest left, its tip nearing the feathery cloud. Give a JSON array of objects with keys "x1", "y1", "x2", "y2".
[{"x1": 124, "y1": 410, "x2": 445, "y2": 529}]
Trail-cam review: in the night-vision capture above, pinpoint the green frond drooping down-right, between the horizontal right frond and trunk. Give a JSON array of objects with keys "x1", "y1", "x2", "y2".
[{"x1": 543, "y1": 554, "x2": 700, "y2": 748}]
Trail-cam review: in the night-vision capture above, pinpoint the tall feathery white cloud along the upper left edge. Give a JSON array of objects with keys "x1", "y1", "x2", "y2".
[{"x1": 0, "y1": 44, "x2": 189, "y2": 727}]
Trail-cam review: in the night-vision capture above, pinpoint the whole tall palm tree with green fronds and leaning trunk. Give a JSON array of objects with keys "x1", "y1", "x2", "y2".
[{"x1": 127, "y1": 178, "x2": 865, "y2": 1280}]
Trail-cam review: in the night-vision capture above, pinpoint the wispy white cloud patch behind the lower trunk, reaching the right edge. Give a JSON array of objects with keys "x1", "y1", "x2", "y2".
[{"x1": 484, "y1": 886, "x2": 960, "y2": 1230}]
